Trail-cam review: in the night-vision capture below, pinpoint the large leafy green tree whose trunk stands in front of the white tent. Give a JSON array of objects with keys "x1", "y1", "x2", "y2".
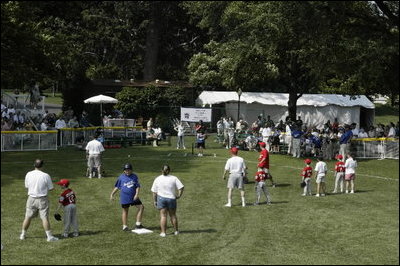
[{"x1": 186, "y1": 1, "x2": 398, "y2": 119}]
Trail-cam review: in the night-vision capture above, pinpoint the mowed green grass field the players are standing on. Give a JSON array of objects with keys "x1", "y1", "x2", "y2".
[{"x1": 1, "y1": 137, "x2": 399, "y2": 265}]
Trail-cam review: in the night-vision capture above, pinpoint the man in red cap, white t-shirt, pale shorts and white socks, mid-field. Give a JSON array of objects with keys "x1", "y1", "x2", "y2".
[{"x1": 222, "y1": 147, "x2": 247, "y2": 207}]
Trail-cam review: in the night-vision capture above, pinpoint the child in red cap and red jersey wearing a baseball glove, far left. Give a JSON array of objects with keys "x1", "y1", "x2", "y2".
[{"x1": 56, "y1": 179, "x2": 79, "y2": 238}]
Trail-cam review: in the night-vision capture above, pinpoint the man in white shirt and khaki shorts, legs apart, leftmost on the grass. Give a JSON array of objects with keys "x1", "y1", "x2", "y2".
[{"x1": 19, "y1": 159, "x2": 58, "y2": 242}]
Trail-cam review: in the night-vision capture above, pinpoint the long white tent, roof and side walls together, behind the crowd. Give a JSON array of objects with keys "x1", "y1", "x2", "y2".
[{"x1": 196, "y1": 91, "x2": 375, "y2": 127}]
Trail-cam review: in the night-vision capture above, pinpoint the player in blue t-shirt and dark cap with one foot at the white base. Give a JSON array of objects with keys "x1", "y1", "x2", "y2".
[{"x1": 110, "y1": 163, "x2": 144, "y2": 231}]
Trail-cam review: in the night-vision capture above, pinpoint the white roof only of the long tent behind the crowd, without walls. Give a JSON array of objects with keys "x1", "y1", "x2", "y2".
[{"x1": 196, "y1": 91, "x2": 375, "y2": 109}]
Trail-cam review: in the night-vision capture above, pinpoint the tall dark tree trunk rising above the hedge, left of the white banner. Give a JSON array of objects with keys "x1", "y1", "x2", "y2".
[{"x1": 143, "y1": 1, "x2": 162, "y2": 81}]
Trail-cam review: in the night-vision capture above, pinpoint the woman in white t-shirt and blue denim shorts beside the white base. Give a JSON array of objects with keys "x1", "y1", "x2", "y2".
[{"x1": 151, "y1": 165, "x2": 184, "y2": 237}]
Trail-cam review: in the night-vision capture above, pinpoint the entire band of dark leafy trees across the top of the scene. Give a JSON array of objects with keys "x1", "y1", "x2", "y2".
[{"x1": 1, "y1": 1, "x2": 399, "y2": 117}]
